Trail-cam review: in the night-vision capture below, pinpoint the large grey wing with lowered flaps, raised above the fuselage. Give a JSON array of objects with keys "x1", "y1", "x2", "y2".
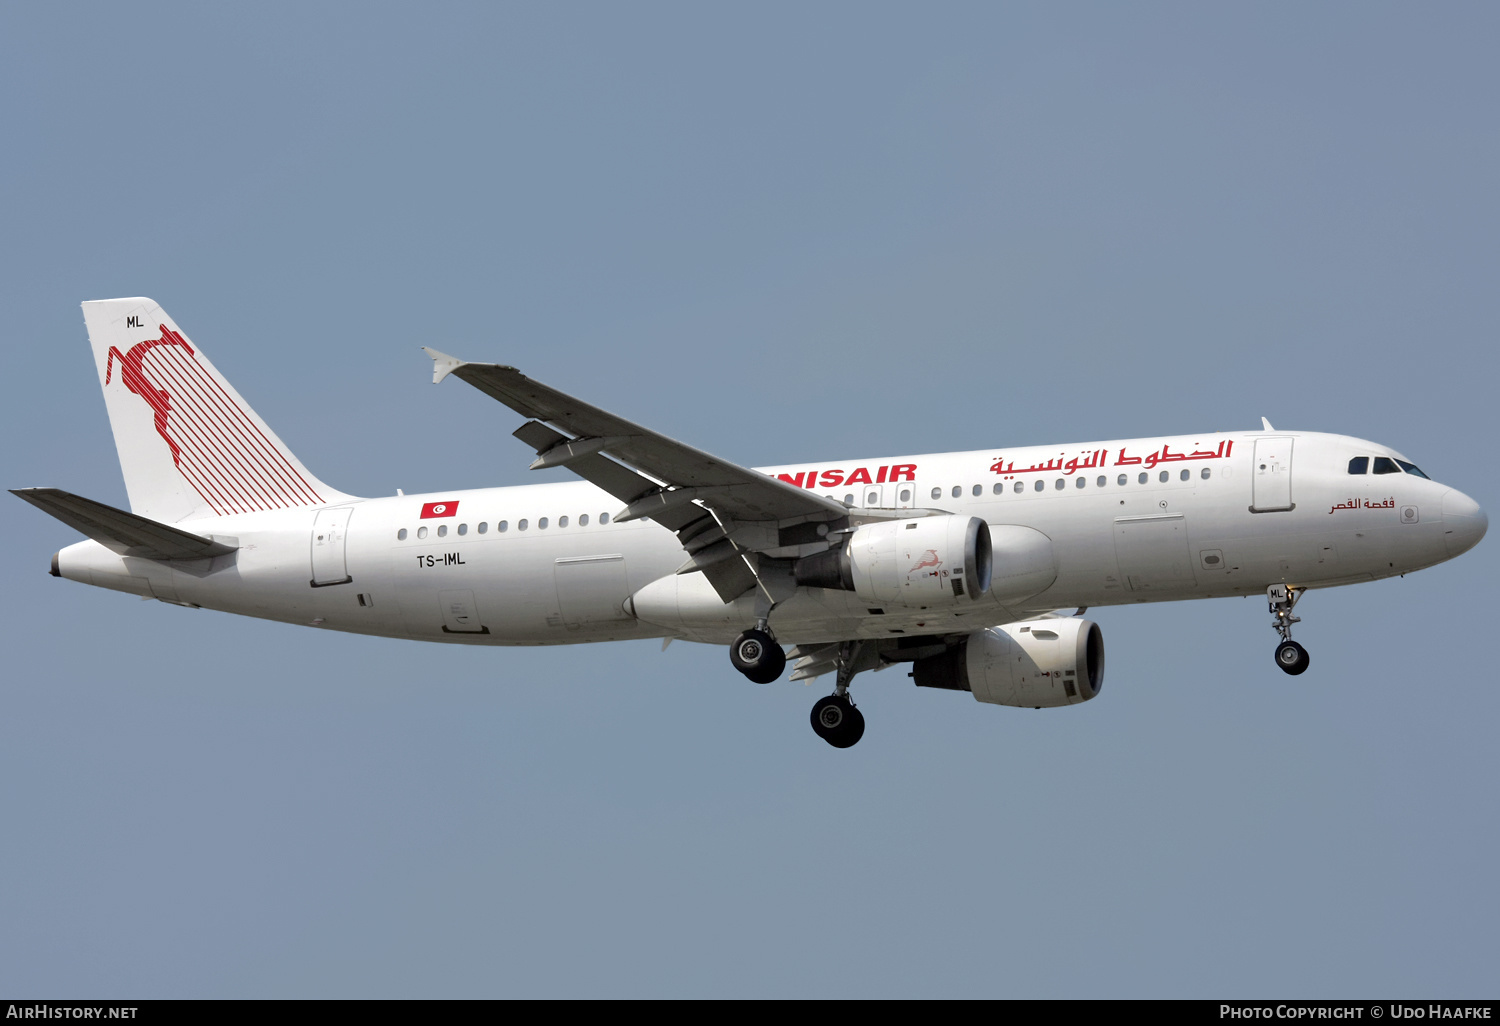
[{"x1": 423, "y1": 347, "x2": 848, "y2": 602}]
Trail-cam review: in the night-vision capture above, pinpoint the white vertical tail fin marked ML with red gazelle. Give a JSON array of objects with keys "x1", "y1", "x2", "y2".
[{"x1": 83, "y1": 299, "x2": 348, "y2": 524}]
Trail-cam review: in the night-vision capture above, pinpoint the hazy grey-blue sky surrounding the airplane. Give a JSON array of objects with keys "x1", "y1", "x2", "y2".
[{"x1": 0, "y1": 3, "x2": 1500, "y2": 998}]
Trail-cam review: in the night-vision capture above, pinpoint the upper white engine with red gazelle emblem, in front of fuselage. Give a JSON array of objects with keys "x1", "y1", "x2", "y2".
[{"x1": 795, "y1": 515, "x2": 995, "y2": 609}]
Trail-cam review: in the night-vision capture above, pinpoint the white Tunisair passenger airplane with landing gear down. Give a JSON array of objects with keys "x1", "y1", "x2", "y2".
[{"x1": 14, "y1": 299, "x2": 1490, "y2": 749}]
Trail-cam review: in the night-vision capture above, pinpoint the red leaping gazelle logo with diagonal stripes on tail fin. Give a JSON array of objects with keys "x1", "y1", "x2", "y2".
[{"x1": 104, "y1": 324, "x2": 324, "y2": 516}]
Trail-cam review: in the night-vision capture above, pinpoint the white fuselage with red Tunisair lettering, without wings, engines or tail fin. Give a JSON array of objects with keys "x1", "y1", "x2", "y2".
[{"x1": 57, "y1": 432, "x2": 1484, "y2": 645}]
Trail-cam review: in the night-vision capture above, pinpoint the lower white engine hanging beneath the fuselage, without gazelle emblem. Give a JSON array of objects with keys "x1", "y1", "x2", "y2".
[{"x1": 912, "y1": 617, "x2": 1104, "y2": 710}]
